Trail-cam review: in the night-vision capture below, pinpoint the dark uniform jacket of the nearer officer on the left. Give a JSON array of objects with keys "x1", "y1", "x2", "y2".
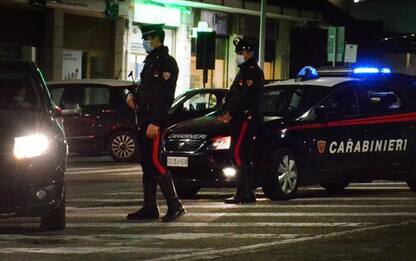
[{"x1": 134, "y1": 46, "x2": 179, "y2": 128}]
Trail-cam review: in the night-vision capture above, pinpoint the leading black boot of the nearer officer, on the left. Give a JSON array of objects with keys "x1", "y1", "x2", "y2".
[{"x1": 127, "y1": 176, "x2": 159, "y2": 220}]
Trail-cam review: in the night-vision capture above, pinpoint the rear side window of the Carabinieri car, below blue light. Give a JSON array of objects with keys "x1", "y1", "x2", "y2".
[{"x1": 357, "y1": 84, "x2": 405, "y2": 115}]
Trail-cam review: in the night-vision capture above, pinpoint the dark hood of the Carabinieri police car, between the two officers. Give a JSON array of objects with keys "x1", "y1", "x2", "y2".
[{"x1": 165, "y1": 116, "x2": 229, "y2": 139}]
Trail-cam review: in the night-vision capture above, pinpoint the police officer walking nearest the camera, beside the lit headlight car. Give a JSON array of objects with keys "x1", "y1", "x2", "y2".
[{"x1": 127, "y1": 24, "x2": 185, "y2": 222}]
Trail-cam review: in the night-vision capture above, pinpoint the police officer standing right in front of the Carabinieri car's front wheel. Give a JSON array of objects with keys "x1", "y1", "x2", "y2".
[{"x1": 220, "y1": 38, "x2": 264, "y2": 204}]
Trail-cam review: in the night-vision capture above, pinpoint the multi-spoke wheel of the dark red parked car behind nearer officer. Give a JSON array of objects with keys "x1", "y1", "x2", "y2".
[{"x1": 108, "y1": 131, "x2": 138, "y2": 162}]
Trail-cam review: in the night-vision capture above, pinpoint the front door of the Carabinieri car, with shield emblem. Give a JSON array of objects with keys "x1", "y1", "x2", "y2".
[{"x1": 304, "y1": 86, "x2": 368, "y2": 182}]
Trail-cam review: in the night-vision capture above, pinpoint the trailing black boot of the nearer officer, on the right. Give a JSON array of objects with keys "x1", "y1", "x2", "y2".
[{"x1": 157, "y1": 173, "x2": 186, "y2": 222}]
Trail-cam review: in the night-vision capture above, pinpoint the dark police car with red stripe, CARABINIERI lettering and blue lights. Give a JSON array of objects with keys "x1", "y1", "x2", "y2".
[{"x1": 162, "y1": 67, "x2": 416, "y2": 200}]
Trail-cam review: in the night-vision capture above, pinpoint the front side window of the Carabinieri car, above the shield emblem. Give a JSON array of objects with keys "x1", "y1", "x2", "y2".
[{"x1": 321, "y1": 86, "x2": 359, "y2": 119}]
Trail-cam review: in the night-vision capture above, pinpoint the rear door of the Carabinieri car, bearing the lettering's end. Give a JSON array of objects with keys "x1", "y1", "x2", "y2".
[{"x1": 357, "y1": 81, "x2": 416, "y2": 176}]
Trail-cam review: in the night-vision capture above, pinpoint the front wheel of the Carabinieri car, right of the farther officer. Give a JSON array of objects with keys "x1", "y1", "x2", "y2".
[{"x1": 262, "y1": 149, "x2": 300, "y2": 200}]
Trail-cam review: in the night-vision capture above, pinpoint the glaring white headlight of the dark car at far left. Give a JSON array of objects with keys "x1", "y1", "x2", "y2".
[{"x1": 13, "y1": 134, "x2": 49, "y2": 159}]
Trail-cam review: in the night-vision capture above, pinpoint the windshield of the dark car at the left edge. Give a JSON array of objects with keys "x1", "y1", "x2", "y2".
[{"x1": 0, "y1": 69, "x2": 40, "y2": 110}]
